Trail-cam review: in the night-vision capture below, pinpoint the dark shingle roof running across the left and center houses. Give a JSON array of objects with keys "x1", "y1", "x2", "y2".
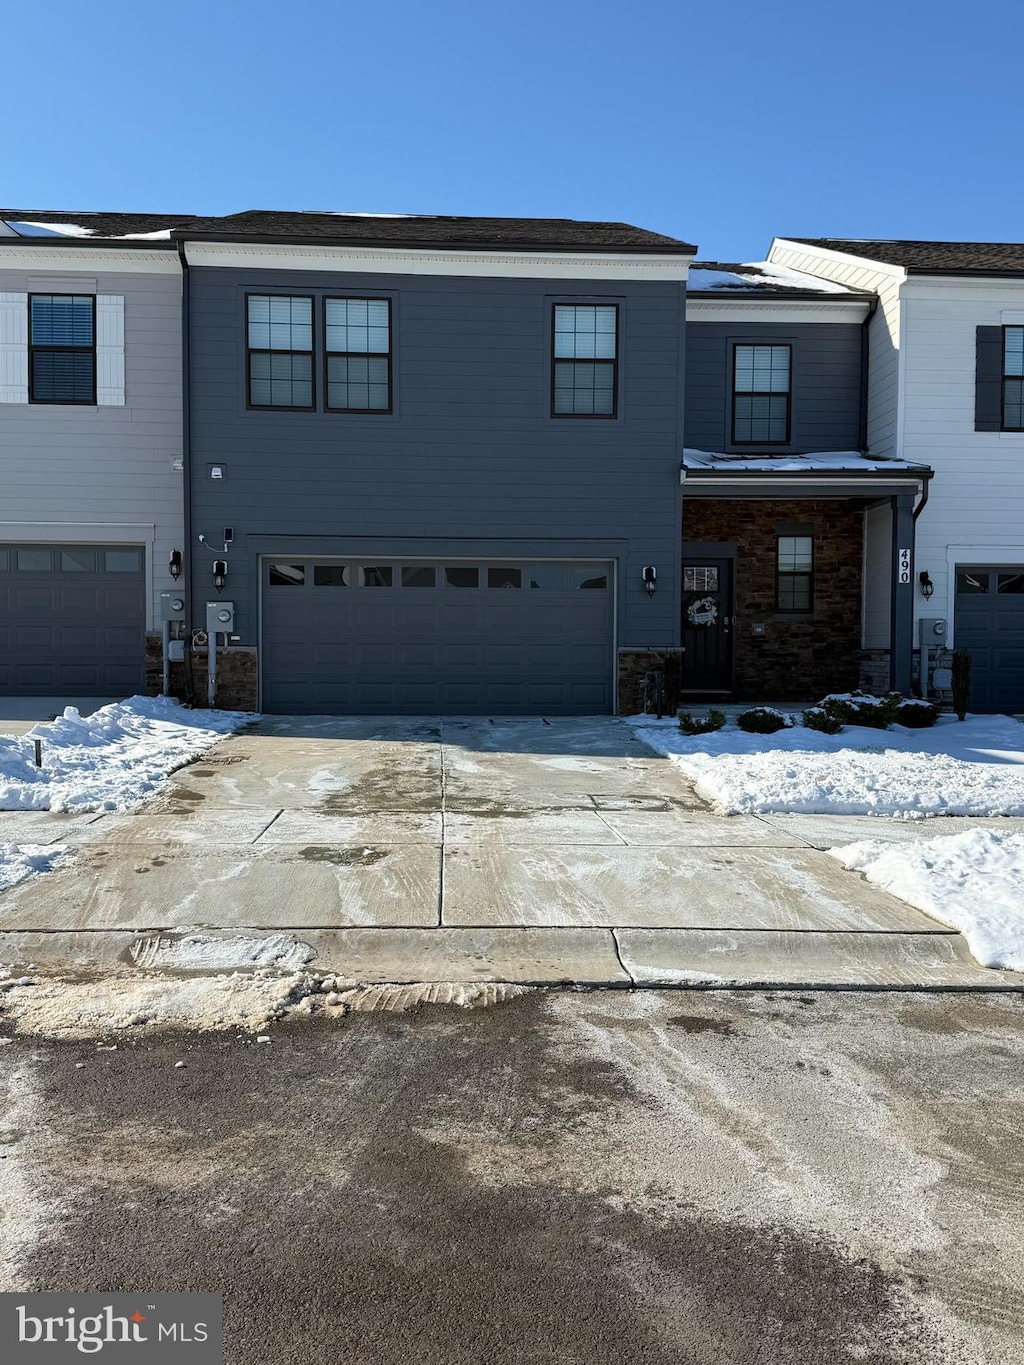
[{"x1": 0, "y1": 209, "x2": 696, "y2": 253}]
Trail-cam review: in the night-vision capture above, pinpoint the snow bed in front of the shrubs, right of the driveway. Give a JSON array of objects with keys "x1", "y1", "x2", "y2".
[{"x1": 631, "y1": 715, "x2": 1024, "y2": 819}]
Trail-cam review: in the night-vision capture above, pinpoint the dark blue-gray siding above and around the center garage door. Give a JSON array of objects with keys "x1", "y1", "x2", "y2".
[{"x1": 191, "y1": 268, "x2": 684, "y2": 647}]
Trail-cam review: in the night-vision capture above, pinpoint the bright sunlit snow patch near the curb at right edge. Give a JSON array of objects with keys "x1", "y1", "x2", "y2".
[{"x1": 829, "y1": 830, "x2": 1024, "y2": 972}]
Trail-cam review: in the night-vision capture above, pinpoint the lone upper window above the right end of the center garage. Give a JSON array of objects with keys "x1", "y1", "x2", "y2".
[{"x1": 552, "y1": 303, "x2": 618, "y2": 418}]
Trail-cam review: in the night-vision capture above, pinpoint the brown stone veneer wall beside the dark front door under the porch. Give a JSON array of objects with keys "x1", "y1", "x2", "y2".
[{"x1": 683, "y1": 498, "x2": 864, "y2": 702}]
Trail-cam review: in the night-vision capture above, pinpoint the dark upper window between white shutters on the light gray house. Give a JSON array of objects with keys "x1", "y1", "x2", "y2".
[{"x1": 29, "y1": 293, "x2": 96, "y2": 404}]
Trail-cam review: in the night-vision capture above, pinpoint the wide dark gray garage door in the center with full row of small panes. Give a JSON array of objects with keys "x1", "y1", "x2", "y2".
[{"x1": 261, "y1": 557, "x2": 613, "y2": 715}]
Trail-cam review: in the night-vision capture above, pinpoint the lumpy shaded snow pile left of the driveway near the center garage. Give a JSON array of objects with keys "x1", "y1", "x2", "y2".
[{"x1": 0, "y1": 696, "x2": 253, "y2": 811}]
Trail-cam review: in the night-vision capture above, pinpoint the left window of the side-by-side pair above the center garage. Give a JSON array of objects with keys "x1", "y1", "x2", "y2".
[{"x1": 246, "y1": 293, "x2": 313, "y2": 411}]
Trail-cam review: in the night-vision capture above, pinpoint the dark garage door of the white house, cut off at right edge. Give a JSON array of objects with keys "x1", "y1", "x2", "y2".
[{"x1": 954, "y1": 564, "x2": 1024, "y2": 714}]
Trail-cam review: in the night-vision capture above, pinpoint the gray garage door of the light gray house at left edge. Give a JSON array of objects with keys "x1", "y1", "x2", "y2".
[{"x1": 0, "y1": 545, "x2": 146, "y2": 696}]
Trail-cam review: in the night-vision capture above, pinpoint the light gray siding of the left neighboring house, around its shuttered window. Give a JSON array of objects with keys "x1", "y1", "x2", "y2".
[{"x1": 0, "y1": 265, "x2": 183, "y2": 624}]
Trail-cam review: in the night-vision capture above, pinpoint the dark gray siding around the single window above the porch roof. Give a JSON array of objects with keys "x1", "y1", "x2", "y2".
[{"x1": 685, "y1": 321, "x2": 863, "y2": 453}]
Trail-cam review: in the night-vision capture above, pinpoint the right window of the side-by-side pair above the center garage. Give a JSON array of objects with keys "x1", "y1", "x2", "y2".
[{"x1": 324, "y1": 299, "x2": 390, "y2": 412}]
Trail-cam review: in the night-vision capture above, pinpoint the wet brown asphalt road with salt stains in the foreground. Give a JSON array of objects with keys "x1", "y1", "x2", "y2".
[{"x1": 0, "y1": 991, "x2": 1024, "y2": 1365}]
